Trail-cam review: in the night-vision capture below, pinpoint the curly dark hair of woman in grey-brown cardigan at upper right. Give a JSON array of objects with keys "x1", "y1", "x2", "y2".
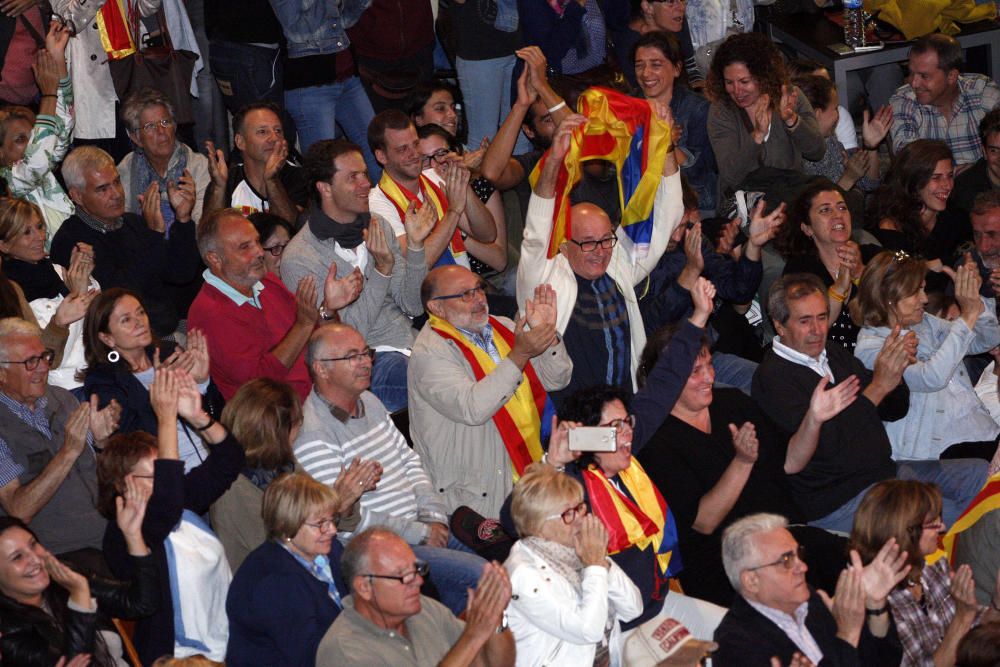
[{"x1": 705, "y1": 32, "x2": 788, "y2": 108}]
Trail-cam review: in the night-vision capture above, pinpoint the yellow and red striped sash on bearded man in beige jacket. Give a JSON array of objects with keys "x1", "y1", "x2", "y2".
[{"x1": 429, "y1": 315, "x2": 551, "y2": 480}]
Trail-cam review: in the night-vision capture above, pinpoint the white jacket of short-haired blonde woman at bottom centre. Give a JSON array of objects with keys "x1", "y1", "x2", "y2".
[{"x1": 504, "y1": 541, "x2": 642, "y2": 667}]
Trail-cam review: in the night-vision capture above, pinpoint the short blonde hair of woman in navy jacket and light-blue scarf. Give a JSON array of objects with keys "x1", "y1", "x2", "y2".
[{"x1": 260, "y1": 472, "x2": 340, "y2": 540}]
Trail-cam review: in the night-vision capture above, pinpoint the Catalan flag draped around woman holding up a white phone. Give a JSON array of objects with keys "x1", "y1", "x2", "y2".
[{"x1": 583, "y1": 458, "x2": 683, "y2": 599}]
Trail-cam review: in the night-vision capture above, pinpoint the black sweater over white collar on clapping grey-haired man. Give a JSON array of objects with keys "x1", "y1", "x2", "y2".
[{"x1": 752, "y1": 342, "x2": 910, "y2": 521}]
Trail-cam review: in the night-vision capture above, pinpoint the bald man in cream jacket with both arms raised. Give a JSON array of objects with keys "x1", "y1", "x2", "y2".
[{"x1": 517, "y1": 111, "x2": 684, "y2": 405}]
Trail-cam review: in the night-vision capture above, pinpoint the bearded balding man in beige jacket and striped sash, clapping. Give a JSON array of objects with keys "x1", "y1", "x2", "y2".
[{"x1": 407, "y1": 264, "x2": 572, "y2": 517}]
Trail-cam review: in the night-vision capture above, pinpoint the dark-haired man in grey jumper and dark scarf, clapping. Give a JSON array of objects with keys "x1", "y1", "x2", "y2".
[{"x1": 281, "y1": 139, "x2": 435, "y2": 412}]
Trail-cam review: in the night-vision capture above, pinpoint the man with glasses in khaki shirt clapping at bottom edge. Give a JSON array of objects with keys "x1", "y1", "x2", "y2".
[{"x1": 316, "y1": 526, "x2": 515, "y2": 667}]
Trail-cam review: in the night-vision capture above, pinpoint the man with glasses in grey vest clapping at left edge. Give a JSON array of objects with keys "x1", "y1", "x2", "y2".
[{"x1": 0, "y1": 317, "x2": 121, "y2": 567}]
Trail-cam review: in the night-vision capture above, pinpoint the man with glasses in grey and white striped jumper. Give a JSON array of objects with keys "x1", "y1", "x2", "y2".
[{"x1": 294, "y1": 324, "x2": 486, "y2": 614}]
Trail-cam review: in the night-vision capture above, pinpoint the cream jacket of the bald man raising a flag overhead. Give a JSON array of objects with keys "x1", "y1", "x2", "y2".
[{"x1": 517, "y1": 170, "x2": 684, "y2": 390}]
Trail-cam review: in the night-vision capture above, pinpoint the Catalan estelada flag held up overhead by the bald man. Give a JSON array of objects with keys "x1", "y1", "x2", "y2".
[{"x1": 529, "y1": 88, "x2": 670, "y2": 258}]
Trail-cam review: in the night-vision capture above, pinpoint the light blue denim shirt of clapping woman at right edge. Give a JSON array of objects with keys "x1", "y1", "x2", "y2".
[{"x1": 854, "y1": 299, "x2": 1000, "y2": 461}]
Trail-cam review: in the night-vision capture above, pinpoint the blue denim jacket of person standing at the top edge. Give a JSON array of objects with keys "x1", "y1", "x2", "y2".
[{"x1": 271, "y1": 0, "x2": 372, "y2": 58}]
